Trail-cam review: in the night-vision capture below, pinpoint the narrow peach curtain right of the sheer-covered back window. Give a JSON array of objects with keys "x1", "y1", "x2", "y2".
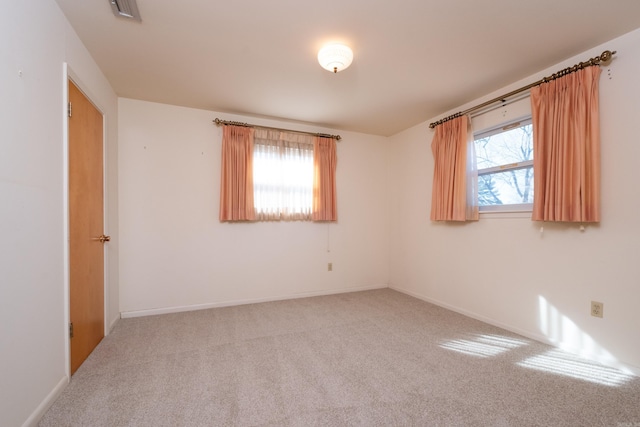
[{"x1": 312, "y1": 137, "x2": 338, "y2": 221}]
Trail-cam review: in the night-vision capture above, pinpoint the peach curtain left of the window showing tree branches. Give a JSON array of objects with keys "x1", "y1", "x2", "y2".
[{"x1": 431, "y1": 116, "x2": 478, "y2": 221}]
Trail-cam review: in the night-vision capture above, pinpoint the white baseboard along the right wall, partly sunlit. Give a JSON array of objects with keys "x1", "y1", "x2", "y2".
[{"x1": 389, "y1": 285, "x2": 640, "y2": 376}]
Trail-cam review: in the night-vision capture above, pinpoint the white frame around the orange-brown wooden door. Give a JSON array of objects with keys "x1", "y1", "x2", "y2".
[{"x1": 62, "y1": 62, "x2": 110, "y2": 380}]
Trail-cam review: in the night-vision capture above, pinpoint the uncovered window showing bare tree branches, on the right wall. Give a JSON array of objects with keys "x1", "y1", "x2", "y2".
[{"x1": 474, "y1": 118, "x2": 533, "y2": 212}]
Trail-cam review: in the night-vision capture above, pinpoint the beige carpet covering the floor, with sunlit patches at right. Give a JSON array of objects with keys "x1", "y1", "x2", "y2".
[{"x1": 40, "y1": 289, "x2": 640, "y2": 427}]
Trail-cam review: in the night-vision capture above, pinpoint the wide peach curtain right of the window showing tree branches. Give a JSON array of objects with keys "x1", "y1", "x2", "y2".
[{"x1": 531, "y1": 66, "x2": 601, "y2": 222}]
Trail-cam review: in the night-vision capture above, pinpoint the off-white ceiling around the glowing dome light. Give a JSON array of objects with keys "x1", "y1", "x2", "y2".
[{"x1": 56, "y1": 0, "x2": 640, "y2": 136}]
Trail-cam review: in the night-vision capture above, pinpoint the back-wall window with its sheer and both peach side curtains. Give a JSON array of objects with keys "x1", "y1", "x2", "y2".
[{"x1": 219, "y1": 125, "x2": 338, "y2": 221}]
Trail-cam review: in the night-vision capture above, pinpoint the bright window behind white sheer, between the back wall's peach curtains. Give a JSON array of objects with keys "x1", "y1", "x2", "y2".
[{"x1": 253, "y1": 129, "x2": 313, "y2": 221}]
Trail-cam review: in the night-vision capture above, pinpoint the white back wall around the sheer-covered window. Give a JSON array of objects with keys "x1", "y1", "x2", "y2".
[{"x1": 118, "y1": 99, "x2": 389, "y2": 316}]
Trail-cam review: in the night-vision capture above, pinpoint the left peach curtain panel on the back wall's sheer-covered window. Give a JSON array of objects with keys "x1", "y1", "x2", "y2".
[{"x1": 220, "y1": 126, "x2": 255, "y2": 221}]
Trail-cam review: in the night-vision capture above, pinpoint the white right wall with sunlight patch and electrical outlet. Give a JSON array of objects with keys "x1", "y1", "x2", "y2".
[{"x1": 390, "y1": 27, "x2": 640, "y2": 372}]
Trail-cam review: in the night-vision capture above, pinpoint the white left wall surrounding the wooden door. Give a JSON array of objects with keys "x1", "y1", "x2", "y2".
[{"x1": 0, "y1": 0, "x2": 118, "y2": 426}]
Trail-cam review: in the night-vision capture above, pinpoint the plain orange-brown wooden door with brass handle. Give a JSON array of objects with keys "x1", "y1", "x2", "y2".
[{"x1": 69, "y1": 81, "x2": 106, "y2": 374}]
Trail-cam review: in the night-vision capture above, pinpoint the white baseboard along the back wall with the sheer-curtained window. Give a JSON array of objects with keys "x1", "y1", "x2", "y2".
[{"x1": 120, "y1": 285, "x2": 388, "y2": 319}]
